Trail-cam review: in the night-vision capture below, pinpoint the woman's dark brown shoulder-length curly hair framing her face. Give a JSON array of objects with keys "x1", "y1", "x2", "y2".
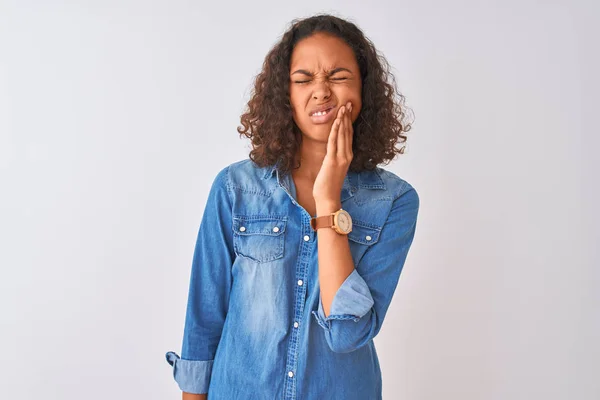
[{"x1": 237, "y1": 14, "x2": 411, "y2": 173}]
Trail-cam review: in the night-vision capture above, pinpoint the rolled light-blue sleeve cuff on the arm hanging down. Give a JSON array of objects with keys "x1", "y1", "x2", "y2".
[{"x1": 166, "y1": 351, "x2": 214, "y2": 394}]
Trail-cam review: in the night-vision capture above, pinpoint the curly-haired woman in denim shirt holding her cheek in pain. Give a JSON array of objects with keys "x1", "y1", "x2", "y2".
[{"x1": 166, "y1": 15, "x2": 419, "y2": 400}]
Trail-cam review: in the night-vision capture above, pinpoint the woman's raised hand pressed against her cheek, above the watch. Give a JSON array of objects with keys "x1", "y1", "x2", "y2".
[{"x1": 313, "y1": 102, "x2": 354, "y2": 212}]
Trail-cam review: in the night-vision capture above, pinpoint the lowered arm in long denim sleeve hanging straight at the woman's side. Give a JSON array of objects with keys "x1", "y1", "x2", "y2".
[{"x1": 166, "y1": 167, "x2": 235, "y2": 399}]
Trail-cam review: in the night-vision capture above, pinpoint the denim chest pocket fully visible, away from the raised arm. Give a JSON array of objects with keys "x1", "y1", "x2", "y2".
[{"x1": 233, "y1": 215, "x2": 287, "y2": 263}]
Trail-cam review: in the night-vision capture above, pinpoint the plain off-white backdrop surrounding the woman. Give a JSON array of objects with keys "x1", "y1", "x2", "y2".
[{"x1": 0, "y1": 0, "x2": 600, "y2": 400}]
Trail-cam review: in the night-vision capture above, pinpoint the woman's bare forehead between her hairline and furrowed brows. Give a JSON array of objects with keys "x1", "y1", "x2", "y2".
[{"x1": 290, "y1": 33, "x2": 358, "y2": 70}]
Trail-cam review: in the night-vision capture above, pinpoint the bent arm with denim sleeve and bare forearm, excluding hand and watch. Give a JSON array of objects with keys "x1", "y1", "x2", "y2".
[{"x1": 312, "y1": 184, "x2": 419, "y2": 353}]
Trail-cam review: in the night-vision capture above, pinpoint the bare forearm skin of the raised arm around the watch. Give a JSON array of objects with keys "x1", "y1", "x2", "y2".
[{"x1": 316, "y1": 201, "x2": 354, "y2": 317}]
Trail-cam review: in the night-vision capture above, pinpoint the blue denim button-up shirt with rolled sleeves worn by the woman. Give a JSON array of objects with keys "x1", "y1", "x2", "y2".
[{"x1": 166, "y1": 159, "x2": 419, "y2": 400}]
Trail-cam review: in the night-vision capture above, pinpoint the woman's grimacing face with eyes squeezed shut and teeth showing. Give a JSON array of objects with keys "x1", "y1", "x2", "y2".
[{"x1": 290, "y1": 33, "x2": 362, "y2": 144}]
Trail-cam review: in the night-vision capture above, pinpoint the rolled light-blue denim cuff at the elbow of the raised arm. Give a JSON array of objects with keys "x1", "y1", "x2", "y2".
[{"x1": 312, "y1": 269, "x2": 375, "y2": 330}]
